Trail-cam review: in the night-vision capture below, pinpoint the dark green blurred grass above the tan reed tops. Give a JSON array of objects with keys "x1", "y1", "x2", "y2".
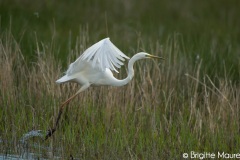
[{"x1": 0, "y1": 0, "x2": 240, "y2": 75}]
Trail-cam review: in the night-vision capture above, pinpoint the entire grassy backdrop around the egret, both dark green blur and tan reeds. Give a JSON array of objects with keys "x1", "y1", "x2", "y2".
[{"x1": 0, "y1": 0, "x2": 240, "y2": 159}]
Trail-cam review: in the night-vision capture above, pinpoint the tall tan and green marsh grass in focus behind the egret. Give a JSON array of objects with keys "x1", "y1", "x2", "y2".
[{"x1": 0, "y1": 31, "x2": 240, "y2": 159}]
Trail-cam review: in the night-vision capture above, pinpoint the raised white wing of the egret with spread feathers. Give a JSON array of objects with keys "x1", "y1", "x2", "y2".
[{"x1": 67, "y1": 38, "x2": 129, "y2": 74}]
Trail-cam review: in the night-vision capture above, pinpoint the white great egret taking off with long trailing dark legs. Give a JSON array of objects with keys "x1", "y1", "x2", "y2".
[{"x1": 46, "y1": 38, "x2": 163, "y2": 139}]
